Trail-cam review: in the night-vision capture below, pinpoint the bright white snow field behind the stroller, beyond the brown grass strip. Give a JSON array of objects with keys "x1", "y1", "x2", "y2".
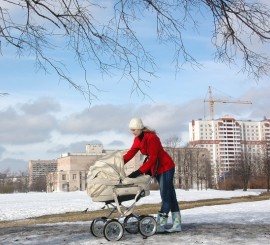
[{"x1": 0, "y1": 189, "x2": 262, "y2": 221}]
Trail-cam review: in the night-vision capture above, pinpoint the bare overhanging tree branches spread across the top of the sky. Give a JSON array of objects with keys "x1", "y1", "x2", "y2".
[{"x1": 0, "y1": 0, "x2": 270, "y2": 100}]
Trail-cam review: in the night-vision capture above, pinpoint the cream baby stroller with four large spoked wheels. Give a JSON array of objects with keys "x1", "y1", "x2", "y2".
[{"x1": 87, "y1": 151, "x2": 157, "y2": 241}]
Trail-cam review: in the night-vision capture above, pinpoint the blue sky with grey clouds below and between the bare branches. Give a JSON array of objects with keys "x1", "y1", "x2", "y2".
[{"x1": 0, "y1": 1, "x2": 270, "y2": 172}]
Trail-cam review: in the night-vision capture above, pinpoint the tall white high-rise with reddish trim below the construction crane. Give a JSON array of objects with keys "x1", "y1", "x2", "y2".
[{"x1": 189, "y1": 116, "x2": 270, "y2": 184}]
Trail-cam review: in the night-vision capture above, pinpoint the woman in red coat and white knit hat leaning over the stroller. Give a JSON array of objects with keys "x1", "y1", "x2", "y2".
[{"x1": 123, "y1": 118, "x2": 181, "y2": 232}]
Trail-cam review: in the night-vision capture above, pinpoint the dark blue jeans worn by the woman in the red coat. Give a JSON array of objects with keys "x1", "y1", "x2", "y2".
[{"x1": 157, "y1": 168, "x2": 179, "y2": 214}]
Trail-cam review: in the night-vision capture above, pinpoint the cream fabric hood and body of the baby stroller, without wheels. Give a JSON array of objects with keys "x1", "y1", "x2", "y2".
[{"x1": 87, "y1": 151, "x2": 151, "y2": 202}]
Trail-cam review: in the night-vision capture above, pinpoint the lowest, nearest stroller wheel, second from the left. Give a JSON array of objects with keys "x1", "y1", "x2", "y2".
[{"x1": 103, "y1": 219, "x2": 124, "y2": 241}]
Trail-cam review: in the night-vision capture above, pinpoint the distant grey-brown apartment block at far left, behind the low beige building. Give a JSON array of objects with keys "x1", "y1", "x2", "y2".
[{"x1": 28, "y1": 159, "x2": 57, "y2": 191}]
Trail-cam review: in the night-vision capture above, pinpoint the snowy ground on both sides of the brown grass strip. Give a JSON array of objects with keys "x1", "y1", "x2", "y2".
[{"x1": 0, "y1": 189, "x2": 270, "y2": 244}]
